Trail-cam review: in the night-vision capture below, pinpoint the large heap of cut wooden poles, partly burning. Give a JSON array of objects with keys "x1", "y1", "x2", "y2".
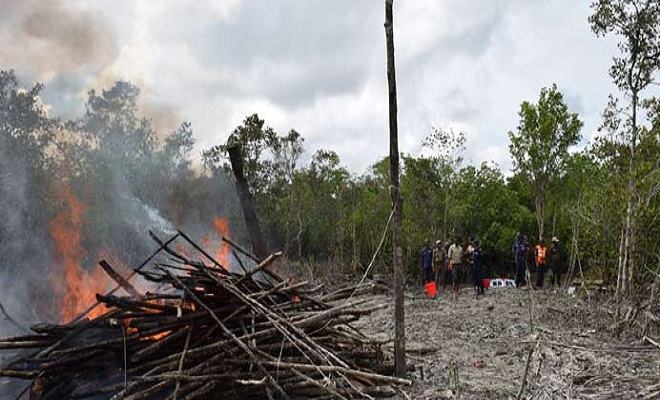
[{"x1": 0, "y1": 232, "x2": 410, "y2": 400}]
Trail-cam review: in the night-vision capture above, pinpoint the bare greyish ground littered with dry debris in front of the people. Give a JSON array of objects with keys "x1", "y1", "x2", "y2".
[{"x1": 357, "y1": 287, "x2": 660, "y2": 400}]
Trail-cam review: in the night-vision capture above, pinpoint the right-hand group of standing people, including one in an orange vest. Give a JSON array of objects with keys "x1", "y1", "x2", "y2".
[{"x1": 513, "y1": 234, "x2": 562, "y2": 289}]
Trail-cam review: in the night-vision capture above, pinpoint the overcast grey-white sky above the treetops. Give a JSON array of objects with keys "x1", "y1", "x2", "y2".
[{"x1": 0, "y1": 0, "x2": 616, "y2": 174}]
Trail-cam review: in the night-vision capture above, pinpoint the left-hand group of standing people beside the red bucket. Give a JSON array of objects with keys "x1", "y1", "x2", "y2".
[{"x1": 422, "y1": 237, "x2": 484, "y2": 297}]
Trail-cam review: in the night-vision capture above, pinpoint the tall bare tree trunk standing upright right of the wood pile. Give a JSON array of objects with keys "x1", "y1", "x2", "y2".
[{"x1": 385, "y1": 0, "x2": 406, "y2": 377}]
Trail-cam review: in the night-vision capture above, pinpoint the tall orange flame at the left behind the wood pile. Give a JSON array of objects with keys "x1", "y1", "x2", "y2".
[{"x1": 49, "y1": 183, "x2": 110, "y2": 322}]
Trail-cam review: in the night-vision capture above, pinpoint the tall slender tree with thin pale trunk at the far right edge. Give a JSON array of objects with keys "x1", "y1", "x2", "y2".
[{"x1": 589, "y1": 0, "x2": 660, "y2": 300}]
